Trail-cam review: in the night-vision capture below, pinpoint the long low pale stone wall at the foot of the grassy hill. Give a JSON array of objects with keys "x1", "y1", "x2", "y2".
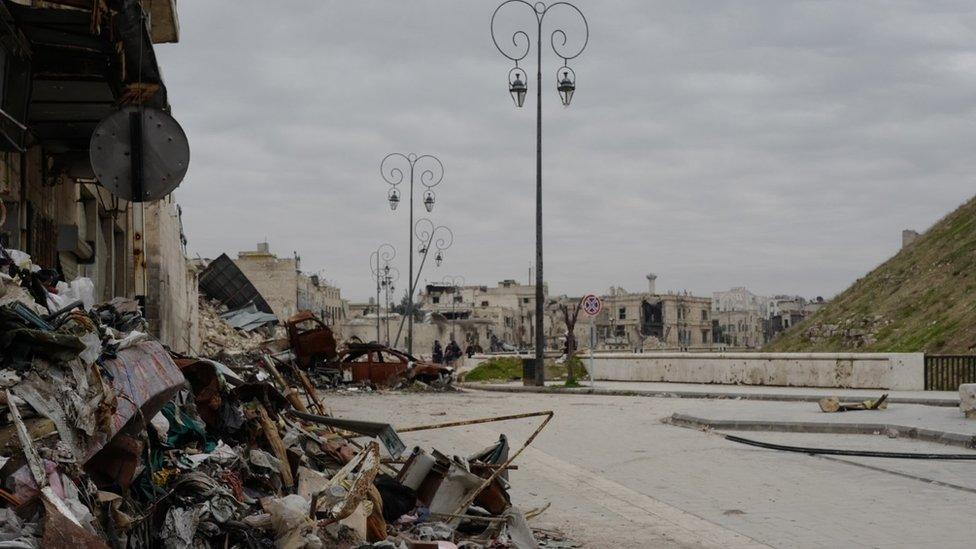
[{"x1": 580, "y1": 353, "x2": 925, "y2": 391}]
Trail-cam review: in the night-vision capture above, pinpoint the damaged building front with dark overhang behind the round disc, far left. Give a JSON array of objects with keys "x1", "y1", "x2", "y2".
[{"x1": 0, "y1": 0, "x2": 197, "y2": 351}]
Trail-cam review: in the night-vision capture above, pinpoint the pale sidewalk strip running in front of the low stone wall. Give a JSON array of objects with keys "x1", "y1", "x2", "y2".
[{"x1": 463, "y1": 380, "x2": 959, "y2": 407}]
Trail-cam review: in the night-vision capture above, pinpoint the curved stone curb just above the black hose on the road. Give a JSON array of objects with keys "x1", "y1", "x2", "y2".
[{"x1": 663, "y1": 414, "x2": 976, "y2": 449}]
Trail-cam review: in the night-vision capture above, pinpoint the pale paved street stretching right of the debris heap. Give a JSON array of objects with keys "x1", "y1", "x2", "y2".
[{"x1": 326, "y1": 391, "x2": 976, "y2": 548}]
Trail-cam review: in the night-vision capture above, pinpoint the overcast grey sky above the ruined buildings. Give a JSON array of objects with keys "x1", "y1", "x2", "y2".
[{"x1": 157, "y1": 0, "x2": 976, "y2": 300}]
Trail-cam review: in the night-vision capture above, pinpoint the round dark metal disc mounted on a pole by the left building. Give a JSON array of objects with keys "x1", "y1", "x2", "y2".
[{"x1": 89, "y1": 107, "x2": 190, "y2": 202}]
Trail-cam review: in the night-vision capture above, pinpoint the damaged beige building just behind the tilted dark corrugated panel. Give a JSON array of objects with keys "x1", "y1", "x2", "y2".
[{"x1": 234, "y1": 242, "x2": 346, "y2": 326}]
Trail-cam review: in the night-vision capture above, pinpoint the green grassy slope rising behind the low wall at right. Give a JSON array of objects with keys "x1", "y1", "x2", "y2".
[{"x1": 765, "y1": 198, "x2": 976, "y2": 353}]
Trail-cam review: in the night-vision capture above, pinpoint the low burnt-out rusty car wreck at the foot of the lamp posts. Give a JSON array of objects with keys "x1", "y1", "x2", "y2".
[{"x1": 327, "y1": 343, "x2": 454, "y2": 387}]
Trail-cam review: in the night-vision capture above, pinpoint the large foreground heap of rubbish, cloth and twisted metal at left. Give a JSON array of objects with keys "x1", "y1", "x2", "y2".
[{"x1": 0, "y1": 248, "x2": 552, "y2": 549}]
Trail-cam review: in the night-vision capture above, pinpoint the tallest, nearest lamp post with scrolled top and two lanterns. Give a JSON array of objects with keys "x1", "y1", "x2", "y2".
[{"x1": 491, "y1": 0, "x2": 590, "y2": 386}]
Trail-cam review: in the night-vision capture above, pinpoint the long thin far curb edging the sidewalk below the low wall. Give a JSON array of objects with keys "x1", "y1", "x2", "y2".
[{"x1": 458, "y1": 383, "x2": 959, "y2": 408}]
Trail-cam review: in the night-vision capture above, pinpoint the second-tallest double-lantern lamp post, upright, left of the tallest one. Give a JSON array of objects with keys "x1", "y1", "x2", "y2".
[{"x1": 380, "y1": 153, "x2": 444, "y2": 354}]
